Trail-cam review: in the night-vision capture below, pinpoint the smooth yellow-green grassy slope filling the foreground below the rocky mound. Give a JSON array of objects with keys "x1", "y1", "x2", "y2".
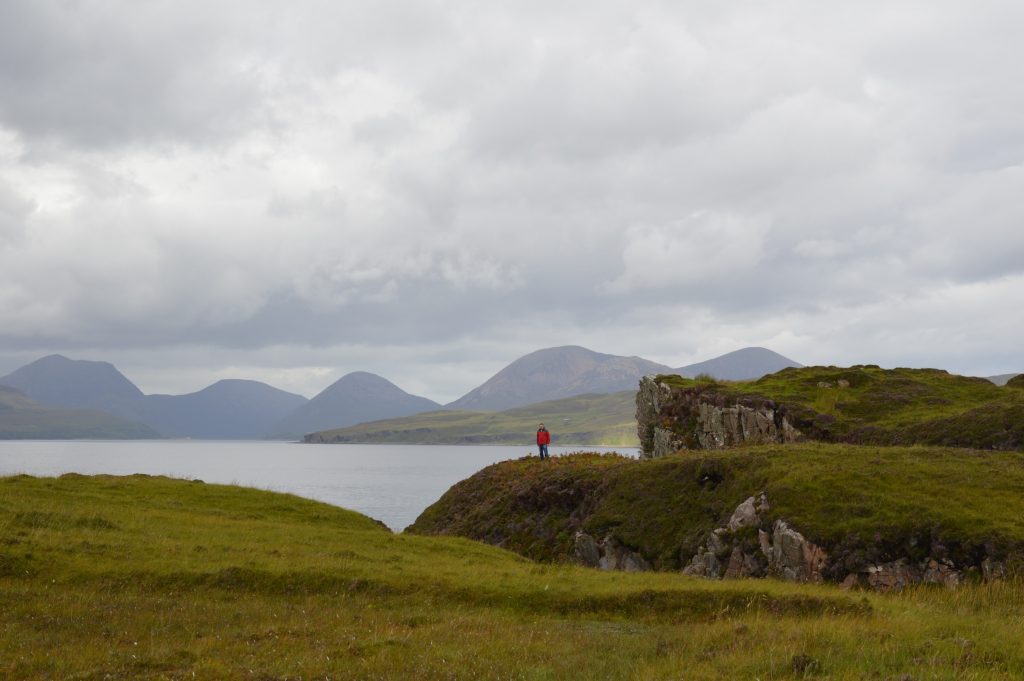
[{"x1": 6, "y1": 471, "x2": 1024, "y2": 680}]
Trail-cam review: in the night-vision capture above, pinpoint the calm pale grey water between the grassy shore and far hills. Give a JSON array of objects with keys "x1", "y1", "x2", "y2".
[{"x1": 0, "y1": 440, "x2": 637, "y2": 530}]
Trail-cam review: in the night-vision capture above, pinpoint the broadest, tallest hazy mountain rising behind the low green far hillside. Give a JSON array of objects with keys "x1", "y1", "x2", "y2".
[{"x1": 447, "y1": 345, "x2": 673, "y2": 412}]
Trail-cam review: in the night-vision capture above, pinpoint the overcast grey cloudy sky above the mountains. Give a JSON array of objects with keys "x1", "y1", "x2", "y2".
[{"x1": 0, "y1": 0, "x2": 1024, "y2": 401}]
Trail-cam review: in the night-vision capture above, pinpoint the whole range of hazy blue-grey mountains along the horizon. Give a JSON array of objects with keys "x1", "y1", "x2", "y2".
[{"x1": 0, "y1": 346, "x2": 800, "y2": 439}]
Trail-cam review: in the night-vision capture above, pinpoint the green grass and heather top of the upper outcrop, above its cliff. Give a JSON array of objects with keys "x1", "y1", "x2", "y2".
[{"x1": 659, "y1": 366, "x2": 1024, "y2": 450}]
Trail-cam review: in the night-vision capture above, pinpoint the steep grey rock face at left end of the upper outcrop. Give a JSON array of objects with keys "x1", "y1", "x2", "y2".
[{"x1": 637, "y1": 376, "x2": 801, "y2": 458}]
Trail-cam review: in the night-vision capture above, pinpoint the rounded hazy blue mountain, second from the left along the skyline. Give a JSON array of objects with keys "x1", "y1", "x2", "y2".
[{"x1": 142, "y1": 379, "x2": 309, "y2": 439}]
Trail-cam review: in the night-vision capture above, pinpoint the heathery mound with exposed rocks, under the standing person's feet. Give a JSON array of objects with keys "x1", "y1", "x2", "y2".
[{"x1": 407, "y1": 442, "x2": 1024, "y2": 590}]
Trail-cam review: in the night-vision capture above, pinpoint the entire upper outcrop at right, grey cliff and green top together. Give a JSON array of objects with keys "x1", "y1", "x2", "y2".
[{"x1": 637, "y1": 366, "x2": 1024, "y2": 455}]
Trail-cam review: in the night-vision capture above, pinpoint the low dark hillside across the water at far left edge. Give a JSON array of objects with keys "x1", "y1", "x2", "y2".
[{"x1": 0, "y1": 386, "x2": 159, "y2": 439}]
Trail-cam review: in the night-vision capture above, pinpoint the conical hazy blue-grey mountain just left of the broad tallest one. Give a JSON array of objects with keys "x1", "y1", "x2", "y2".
[{"x1": 267, "y1": 372, "x2": 441, "y2": 437}]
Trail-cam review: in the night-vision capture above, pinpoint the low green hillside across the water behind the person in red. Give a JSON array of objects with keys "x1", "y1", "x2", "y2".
[{"x1": 306, "y1": 390, "x2": 639, "y2": 446}]
